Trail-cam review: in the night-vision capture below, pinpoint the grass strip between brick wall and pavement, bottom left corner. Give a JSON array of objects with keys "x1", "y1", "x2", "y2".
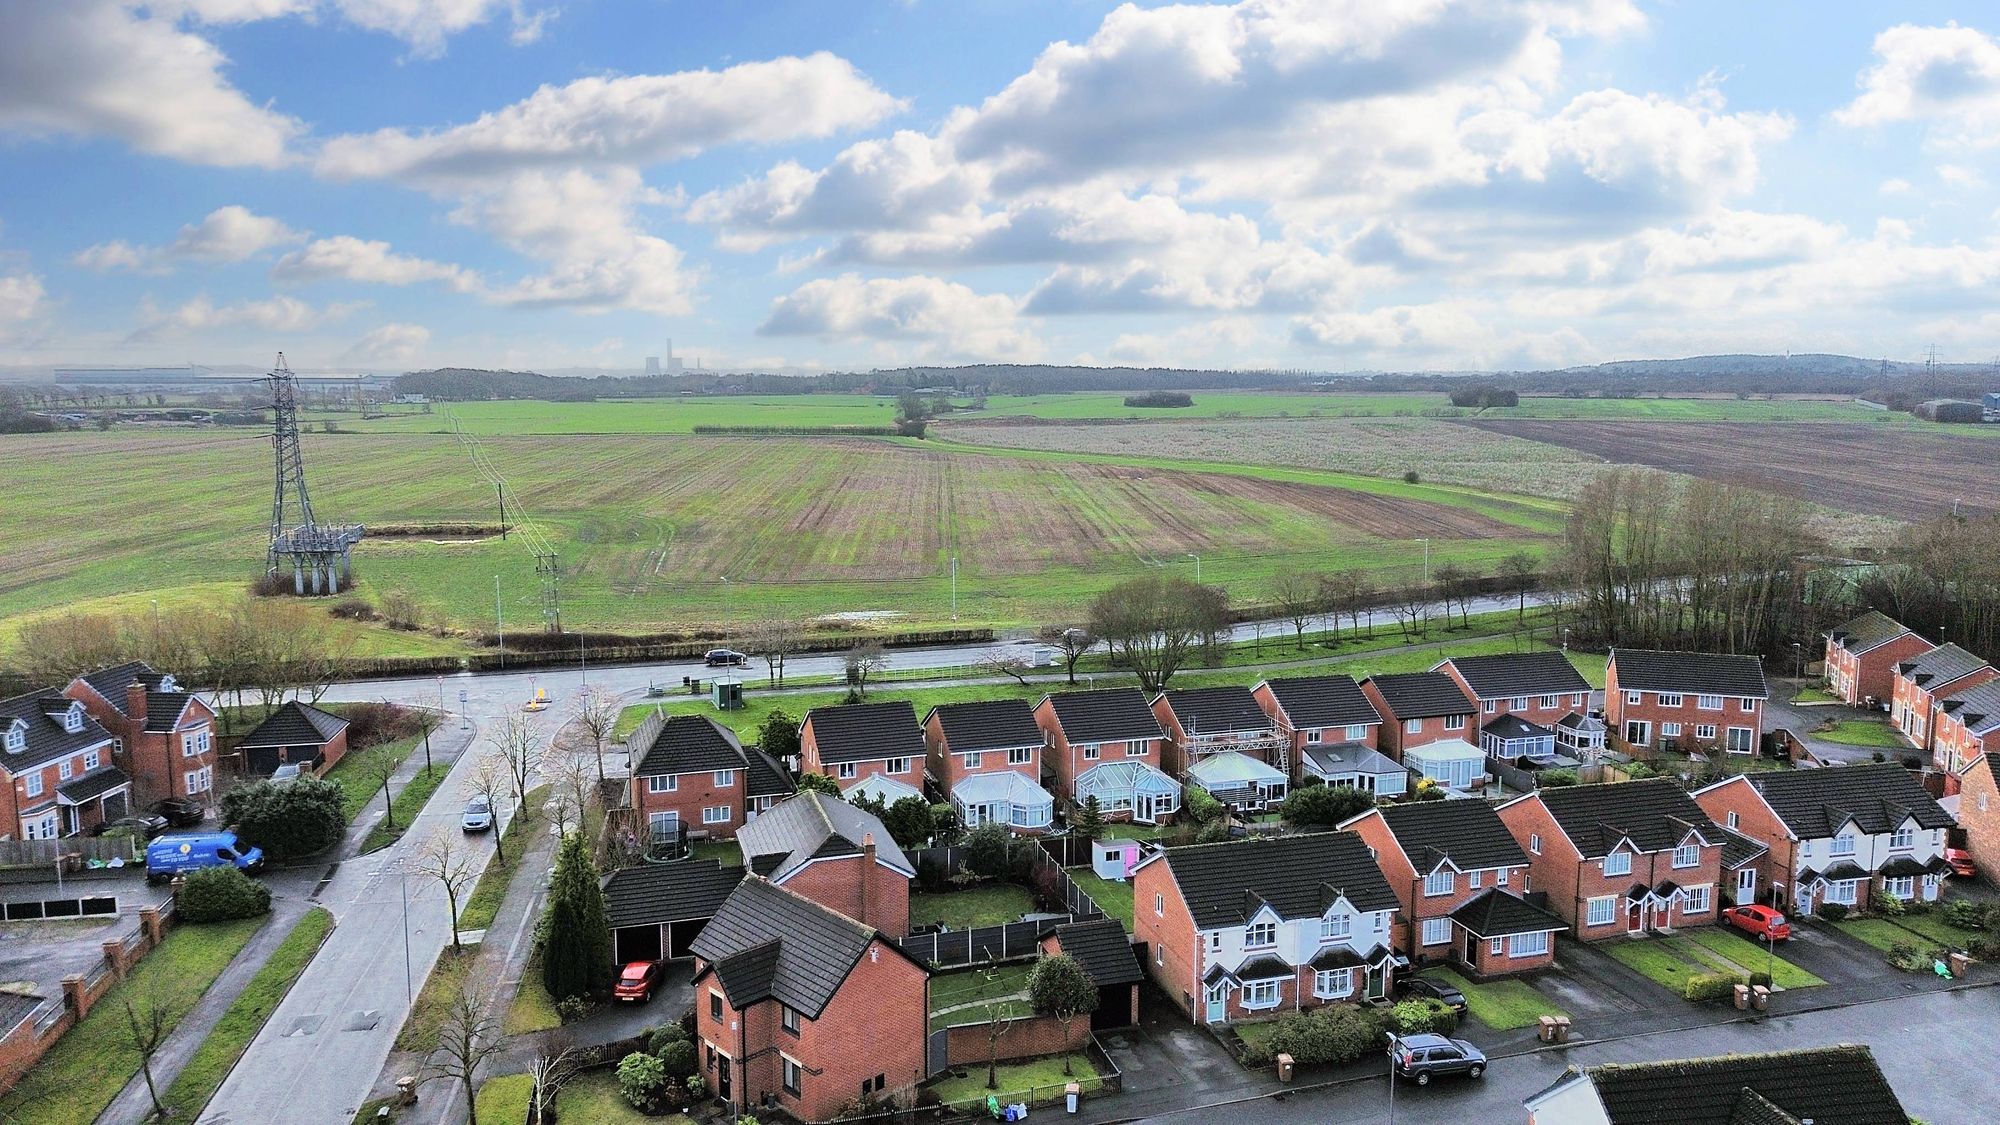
[{"x1": 0, "y1": 919, "x2": 264, "y2": 1125}]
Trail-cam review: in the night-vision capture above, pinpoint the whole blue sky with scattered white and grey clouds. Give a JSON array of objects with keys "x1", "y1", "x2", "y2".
[{"x1": 0, "y1": 0, "x2": 2000, "y2": 370}]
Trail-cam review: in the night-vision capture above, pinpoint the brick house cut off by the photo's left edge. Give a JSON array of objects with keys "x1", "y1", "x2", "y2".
[{"x1": 0, "y1": 687, "x2": 132, "y2": 841}]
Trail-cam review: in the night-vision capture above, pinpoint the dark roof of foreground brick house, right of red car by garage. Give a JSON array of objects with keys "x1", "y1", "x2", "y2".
[{"x1": 688, "y1": 876, "x2": 908, "y2": 1019}]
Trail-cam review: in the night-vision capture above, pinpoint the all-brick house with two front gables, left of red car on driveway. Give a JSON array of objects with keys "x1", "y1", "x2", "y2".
[{"x1": 1498, "y1": 777, "x2": 1726, "y2": 941}]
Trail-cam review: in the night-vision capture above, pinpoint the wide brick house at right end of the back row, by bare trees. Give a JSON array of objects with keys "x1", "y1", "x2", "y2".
[{"x1": 1604, "y1": 649, "x2": 1770, "y2": 755}]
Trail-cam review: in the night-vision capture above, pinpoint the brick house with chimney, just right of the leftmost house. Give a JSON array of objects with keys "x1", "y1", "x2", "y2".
[{"x1": 64, "y1": 661, "x2": 216, "y2": 809}]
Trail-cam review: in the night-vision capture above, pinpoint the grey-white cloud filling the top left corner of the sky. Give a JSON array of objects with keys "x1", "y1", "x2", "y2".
[{"x1": 0, "y1": 0, "x2": 302, "y2": 168}]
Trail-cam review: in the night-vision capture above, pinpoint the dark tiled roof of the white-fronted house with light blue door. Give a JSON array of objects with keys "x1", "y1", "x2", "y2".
[{"x1": 1148, "y1": 833, "x2": 1396, "y2": 929}]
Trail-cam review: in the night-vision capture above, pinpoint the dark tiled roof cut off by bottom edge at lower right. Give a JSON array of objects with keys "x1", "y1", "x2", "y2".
[{"x1": 1572, "y1": 1043, "x2": 1910, "y2": 1125}]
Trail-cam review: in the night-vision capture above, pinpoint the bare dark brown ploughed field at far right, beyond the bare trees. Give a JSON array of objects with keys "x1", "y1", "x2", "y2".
[{"x1": 1460, "y1": 418, "x2": 2000, "y2": 520}]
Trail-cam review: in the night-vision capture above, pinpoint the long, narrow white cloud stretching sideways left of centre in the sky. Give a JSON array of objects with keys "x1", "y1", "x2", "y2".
[{"x1": 318, "y1": 52, "x2": 898, "y2": 184}]
